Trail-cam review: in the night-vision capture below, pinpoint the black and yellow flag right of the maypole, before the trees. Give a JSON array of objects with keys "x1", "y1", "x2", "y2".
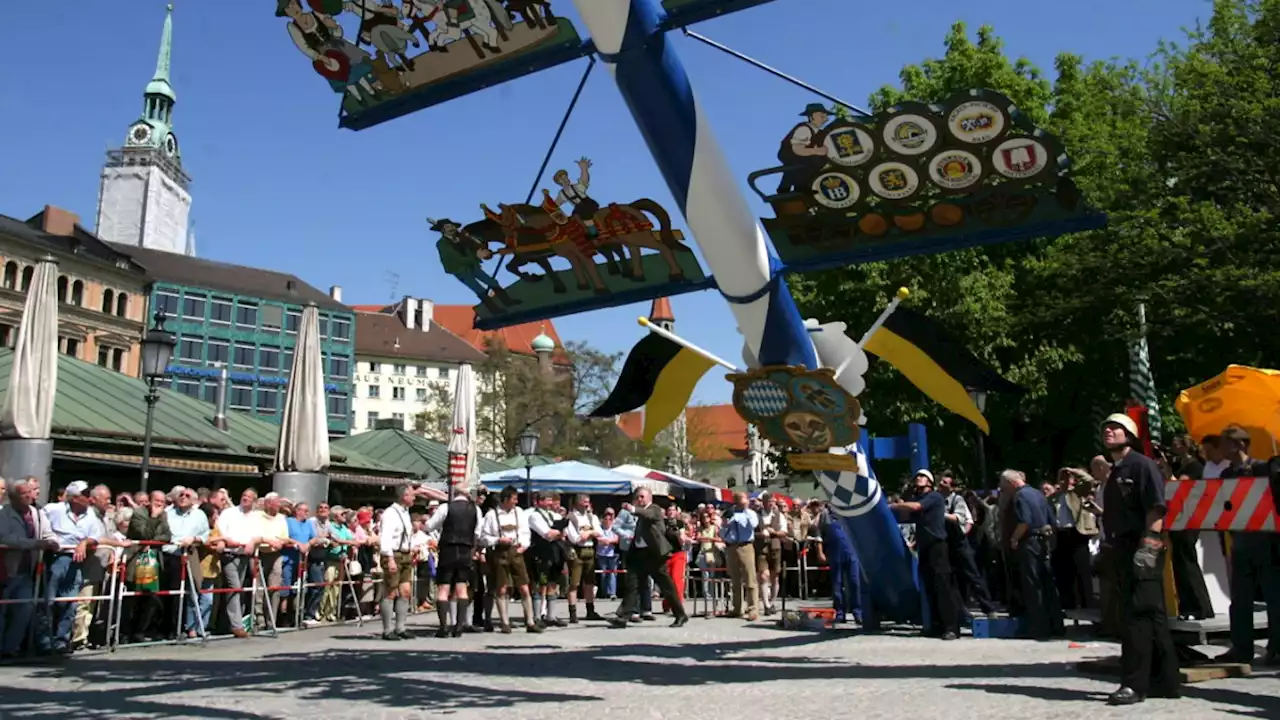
[{"x1": 863, "y1": 307, "x2": 1023, "y2": 433}]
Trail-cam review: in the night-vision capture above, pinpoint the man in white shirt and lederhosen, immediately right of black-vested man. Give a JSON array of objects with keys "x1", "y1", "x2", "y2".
[{"x1": 481, "y1": 486, "x2": 543, "y2": 634}]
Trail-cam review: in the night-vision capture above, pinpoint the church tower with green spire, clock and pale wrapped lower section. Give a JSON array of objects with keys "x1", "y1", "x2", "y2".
[{"x1": 96, "y1": 5, "x2": 195, "y2": 255}]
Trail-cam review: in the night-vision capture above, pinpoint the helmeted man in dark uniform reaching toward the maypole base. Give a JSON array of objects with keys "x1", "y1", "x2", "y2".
[{"x1": 888, "y1": 470, "x2": 960, "y2": 641}]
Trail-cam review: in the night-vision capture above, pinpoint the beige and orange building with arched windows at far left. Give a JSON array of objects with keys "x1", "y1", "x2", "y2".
[{"x1": 0, "y1": 206, "x2": 151, "y2": 377}]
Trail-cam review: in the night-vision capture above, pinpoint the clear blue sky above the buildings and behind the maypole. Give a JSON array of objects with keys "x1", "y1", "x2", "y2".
[{"x1": 0, "y1": 0, "x2": 1210, "y2": 402}]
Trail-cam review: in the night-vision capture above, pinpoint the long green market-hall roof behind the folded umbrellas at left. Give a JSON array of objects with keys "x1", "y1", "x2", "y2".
[{"x1": 0, "y1": 348, "x2": 412, "y2": 480}]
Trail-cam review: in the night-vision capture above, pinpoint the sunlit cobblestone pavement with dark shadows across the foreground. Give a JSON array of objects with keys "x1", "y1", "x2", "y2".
[{"x1": 0, "y1": 605, "x2": 1280, "y2": 720}]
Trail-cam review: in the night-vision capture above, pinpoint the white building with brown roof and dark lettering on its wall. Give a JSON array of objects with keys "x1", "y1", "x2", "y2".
[{"x1": 352, "y1": 297, "x2": 485, "y2": 430}]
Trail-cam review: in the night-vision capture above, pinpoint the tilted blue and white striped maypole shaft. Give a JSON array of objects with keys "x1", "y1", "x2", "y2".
[{"x1": 575, "y1": 0, "x2": 919, "y2": 618}]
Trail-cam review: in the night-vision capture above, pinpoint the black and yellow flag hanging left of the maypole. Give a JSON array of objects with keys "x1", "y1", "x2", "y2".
[{"x1": 591, "y1": 333, "x2": 716, "y2": 442}]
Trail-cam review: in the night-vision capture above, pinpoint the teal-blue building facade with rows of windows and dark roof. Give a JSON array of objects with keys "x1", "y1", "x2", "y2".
[{"x1": 111, "y1": 243, "x2": 356, "y2": 437}]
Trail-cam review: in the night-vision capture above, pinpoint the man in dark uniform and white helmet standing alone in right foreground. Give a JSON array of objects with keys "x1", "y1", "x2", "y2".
[{"x1": 1102, "y1": 413, "x2": 1180, "y2": 705}]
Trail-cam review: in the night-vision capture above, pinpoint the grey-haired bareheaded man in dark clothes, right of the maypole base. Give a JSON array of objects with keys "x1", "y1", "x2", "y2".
[{"x1": 1000, "y1": 470, "x2": 1065, "y2": 641}]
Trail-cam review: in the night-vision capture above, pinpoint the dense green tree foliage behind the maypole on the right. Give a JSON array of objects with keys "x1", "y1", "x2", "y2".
[{"x1": 790, "y1": 0, "x2": 1280, "y2": 482}]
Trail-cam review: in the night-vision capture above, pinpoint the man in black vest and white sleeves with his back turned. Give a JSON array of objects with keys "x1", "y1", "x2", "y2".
[{"x1": 426, "y1": 492, "x2": 483, "y2": 638}]
